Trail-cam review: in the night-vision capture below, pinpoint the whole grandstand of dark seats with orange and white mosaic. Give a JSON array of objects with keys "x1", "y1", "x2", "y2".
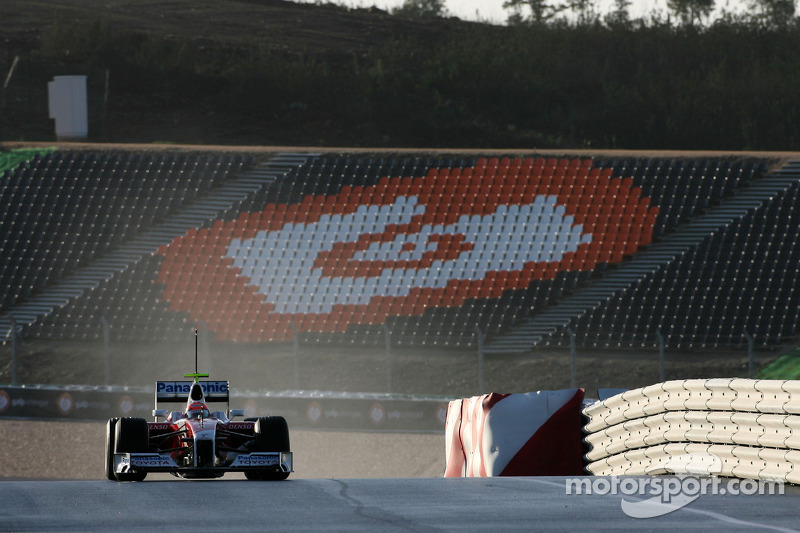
[{"x1": 0, "y1": 149, "x2": 800, "y2": 353}]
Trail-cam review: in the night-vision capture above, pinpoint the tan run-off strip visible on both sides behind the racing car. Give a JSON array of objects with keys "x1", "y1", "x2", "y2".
[{"x1": 0, "y1": 419, "x2": 445, "y2": 480}]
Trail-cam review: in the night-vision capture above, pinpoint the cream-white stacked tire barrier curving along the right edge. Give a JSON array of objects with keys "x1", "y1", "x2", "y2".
[{"x1": 584, "y1": 378, "x2": 800, "y2": 483}]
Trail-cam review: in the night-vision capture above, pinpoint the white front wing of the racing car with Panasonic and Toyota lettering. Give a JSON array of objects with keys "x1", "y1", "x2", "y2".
[{"x1": 114, "y1": 452, "x2": 294, "y2": 475}]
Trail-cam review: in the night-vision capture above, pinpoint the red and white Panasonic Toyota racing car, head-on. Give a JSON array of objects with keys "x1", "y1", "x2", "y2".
[{"x1": 105, "y1": 373, "x2": 293, "y2": 481}]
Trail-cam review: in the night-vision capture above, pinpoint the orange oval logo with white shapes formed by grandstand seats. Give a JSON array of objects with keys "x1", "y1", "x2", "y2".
[{"x1": 157, "y1": 160, "x2": 658, "y2": 342}]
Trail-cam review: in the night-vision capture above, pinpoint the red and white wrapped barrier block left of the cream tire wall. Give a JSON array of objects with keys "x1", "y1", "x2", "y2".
[{"x1": 444, "y1": 389, "x2": 584, "y2": 477}]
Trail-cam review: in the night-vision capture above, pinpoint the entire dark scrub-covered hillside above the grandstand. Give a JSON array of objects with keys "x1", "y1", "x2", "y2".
[{"x1": 0, "y1": 0, "x2": 800, "y2": 151}]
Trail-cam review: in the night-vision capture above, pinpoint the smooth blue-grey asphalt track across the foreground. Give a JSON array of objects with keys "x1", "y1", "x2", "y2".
[{"x1": 0, "y1": 477, "x2": 800, "y2": 532}]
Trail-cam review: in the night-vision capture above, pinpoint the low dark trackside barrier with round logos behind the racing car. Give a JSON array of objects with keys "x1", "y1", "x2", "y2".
[{"x1": 0, "y1": 386, "x2": 448, "y2": 433}]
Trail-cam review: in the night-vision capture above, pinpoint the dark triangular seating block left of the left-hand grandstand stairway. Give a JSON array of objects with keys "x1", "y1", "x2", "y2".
[{"x1": 0, "y1": 152, "x2": 250, "y2": 310}]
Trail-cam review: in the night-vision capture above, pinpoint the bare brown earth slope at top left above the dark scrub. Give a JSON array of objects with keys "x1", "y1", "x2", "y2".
[{"x1": 0, "y1": 0, "x2": 466, "y2": 56}]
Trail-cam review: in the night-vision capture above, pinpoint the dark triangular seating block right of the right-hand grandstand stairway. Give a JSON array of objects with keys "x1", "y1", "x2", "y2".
[{"x1": 576, "y1": 175, "x2": 800, "y2": 348}]
